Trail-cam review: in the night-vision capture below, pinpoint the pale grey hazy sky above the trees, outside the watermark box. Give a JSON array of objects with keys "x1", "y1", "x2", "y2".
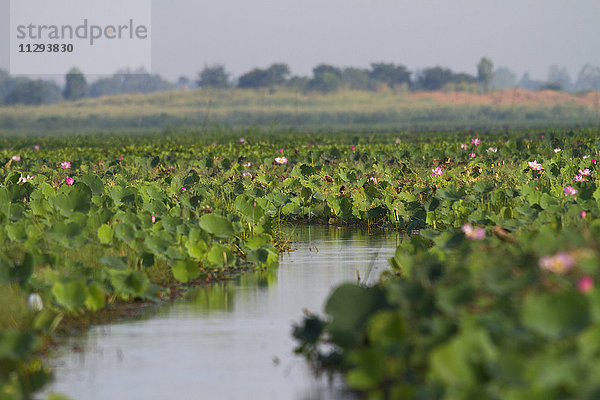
[{"x1": 0, "y1": 0, "x2": 600, "y2": 79}]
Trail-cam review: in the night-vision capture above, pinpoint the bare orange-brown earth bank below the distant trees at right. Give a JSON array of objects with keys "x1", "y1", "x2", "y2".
[{"x1": 411, "y1": 89, "x2": 600, "y2": 108}]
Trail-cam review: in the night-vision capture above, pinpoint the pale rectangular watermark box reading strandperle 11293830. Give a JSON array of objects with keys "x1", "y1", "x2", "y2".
[{"x1": 10, "y1": 0, "x2": 152, "y2": 75}]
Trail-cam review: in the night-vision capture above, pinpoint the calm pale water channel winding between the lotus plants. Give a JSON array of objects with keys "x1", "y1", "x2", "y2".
[{"x1": 42, "y1": 227, "x2": 396, "y2": 400}]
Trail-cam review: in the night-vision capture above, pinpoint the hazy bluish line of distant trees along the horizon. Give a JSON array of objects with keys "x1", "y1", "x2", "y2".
[{"x1": 0, "y1": 57, "x2": 600, "y2": 105}]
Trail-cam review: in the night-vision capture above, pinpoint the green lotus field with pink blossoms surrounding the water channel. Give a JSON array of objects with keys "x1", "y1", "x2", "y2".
[{"x1": 0, "y1": 129, "x2": 600, "y2": 399}]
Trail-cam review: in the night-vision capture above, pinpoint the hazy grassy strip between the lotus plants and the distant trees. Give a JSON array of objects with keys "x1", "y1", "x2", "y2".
[{"x1": 0, "y1": 88, "x2": 600, "y2": 136}]
